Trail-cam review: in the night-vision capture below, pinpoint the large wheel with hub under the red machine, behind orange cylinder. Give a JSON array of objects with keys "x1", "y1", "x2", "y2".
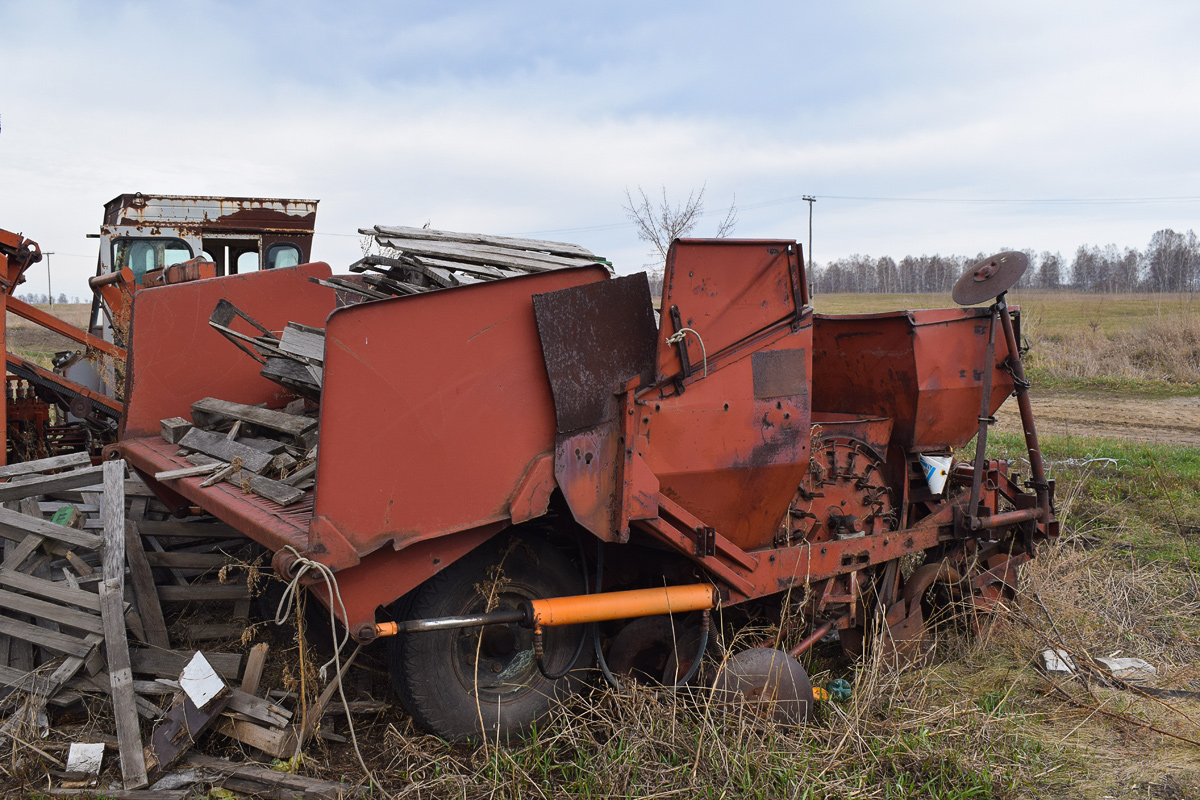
[{"x1": 388, "y1": 529, "x2": 592, "y2": 740}]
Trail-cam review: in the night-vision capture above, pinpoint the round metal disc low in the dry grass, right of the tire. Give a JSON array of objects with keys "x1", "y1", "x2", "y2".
[{"x1": 713, "y1": 648, "x2": 812, "y2": 724}]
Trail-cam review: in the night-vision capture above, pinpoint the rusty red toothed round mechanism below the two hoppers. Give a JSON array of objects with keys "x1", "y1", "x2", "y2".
[{"x1": 776, "y1": 437, "x2": 898, "y2": 546}]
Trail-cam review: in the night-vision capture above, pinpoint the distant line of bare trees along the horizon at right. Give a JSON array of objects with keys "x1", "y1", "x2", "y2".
[{"x1": 810, "y1": 228, "x2": 1200, "y2": 294}]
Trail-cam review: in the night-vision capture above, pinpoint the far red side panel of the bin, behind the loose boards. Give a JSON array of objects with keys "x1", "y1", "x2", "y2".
[{"x1": 121, "y1": 263, "x2": 334, "y2": 438}]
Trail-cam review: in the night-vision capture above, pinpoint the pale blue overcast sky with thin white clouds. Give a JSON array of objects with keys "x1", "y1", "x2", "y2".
[{"x1": 0, "y1": 0, "x2": 1200, "y2": 296}]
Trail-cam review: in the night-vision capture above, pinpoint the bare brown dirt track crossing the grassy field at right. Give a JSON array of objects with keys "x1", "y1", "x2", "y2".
[{"x1": 996, "y1": 393, "x2": 1200, "y2": 447}]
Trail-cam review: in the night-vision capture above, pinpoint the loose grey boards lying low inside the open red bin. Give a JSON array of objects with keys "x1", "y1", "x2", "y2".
[{"x1": 155, "y1": 397, "x2": 317, "y2": 506}]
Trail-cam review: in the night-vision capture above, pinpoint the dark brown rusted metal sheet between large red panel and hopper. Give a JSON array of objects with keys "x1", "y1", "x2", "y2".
[{"x1": 533, "y1": 272, "x2": 655, "y2": 433}]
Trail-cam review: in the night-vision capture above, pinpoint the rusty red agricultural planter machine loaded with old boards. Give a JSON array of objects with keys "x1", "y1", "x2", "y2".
[{"x1": 100, "y1": 229, "x2": 1057, "y2": 738}]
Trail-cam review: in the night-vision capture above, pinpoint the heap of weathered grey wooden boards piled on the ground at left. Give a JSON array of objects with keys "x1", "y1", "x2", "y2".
[{"x1": 0, "y1": 453, "x2": 367, "y2": 799}]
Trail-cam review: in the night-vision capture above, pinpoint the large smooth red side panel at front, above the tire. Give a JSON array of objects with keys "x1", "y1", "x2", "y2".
[{"x1": 313, "y1": 266, "x2": 608, "y2": 563}]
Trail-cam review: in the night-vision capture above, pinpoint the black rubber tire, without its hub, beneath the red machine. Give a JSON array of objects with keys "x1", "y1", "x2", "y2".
[{"x1": 388, "y1": 529, "x2": 593, "y2": 741}]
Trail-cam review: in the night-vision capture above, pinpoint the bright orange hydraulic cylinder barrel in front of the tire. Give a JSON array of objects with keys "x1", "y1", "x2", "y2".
[{"x1": 529, "y1": 583, "x2": 716, "y2": 627}]
